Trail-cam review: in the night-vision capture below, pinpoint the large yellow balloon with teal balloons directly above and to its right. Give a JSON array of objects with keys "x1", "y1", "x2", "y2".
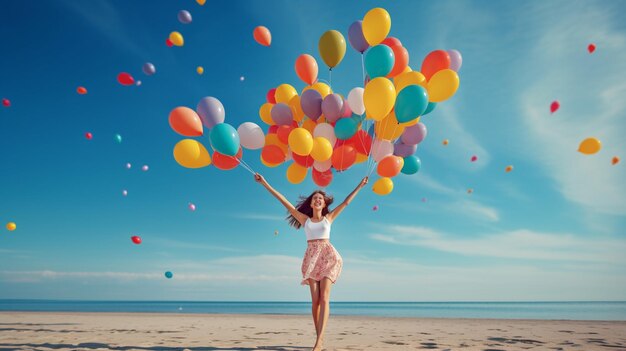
[{"x1": 363, "y1": 77, "x2": 396, "y2": 121}]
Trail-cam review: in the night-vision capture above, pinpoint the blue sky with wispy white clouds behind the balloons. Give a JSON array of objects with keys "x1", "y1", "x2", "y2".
[{"x1": 0, "y1": 0, "x2": 626, "y2": 301}]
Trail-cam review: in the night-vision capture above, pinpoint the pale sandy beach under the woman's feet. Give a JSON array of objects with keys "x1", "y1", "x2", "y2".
[{"x1": 0, "y1": 312, "x2": 626, "y2": 351}]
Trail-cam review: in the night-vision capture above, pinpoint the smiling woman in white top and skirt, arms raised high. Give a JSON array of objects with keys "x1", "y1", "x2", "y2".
[{"x1": 254, "y1": 173, "x2": 368, "y2": 351}]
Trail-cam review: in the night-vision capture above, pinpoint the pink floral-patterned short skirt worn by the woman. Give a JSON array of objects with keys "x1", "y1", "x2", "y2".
[{"x1": 300, "y1": 240, "x2": 343, "y2": 285}]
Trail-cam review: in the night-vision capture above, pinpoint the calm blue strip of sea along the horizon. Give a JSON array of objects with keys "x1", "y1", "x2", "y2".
[{"x1": 0, "y1": 300, "x2": 626, "y2": 320}]
